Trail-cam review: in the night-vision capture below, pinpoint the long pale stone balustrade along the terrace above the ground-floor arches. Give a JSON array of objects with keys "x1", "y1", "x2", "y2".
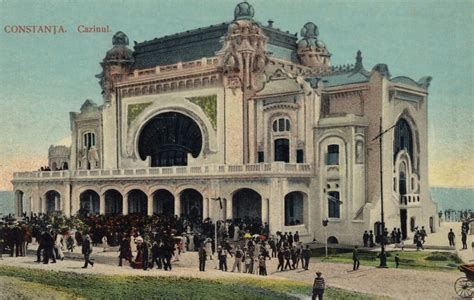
[{"x1": 13, "y1": 162, "x2": 313, "y2": 181}]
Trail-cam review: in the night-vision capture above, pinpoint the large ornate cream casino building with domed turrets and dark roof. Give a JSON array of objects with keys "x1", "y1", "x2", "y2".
[{"x1": 13, "y1": 2, "x2": 438, "y2": 244}]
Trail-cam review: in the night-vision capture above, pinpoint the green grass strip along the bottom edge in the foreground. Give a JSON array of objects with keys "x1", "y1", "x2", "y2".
[{"x1": 0, "y1": 266, "x2": 374, "y2": 299}]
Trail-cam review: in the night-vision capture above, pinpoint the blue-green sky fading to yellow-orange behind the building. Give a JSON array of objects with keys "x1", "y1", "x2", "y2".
[{"x1": 0, "y1": 0, "x2": 474, "y2": 190}]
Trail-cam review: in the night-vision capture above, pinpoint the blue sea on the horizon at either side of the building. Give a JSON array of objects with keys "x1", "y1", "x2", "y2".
[{"x1": 0, "y1": 188, "x2": 474, "y2": 214}]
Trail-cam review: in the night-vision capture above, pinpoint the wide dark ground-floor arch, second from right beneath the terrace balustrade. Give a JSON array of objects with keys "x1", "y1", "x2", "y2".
[{"x1": 232, "y1": 188, "x2": 262, "y2": 221}]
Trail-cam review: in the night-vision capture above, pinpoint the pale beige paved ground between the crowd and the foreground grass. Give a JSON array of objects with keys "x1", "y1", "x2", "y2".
[{"x1": 0, "y1": 223, "x2": 473, "y2": 299}]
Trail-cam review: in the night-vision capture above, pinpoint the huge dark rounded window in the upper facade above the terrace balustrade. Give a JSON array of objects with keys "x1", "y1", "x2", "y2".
[{"x1": 138, "y1": 112, "x2": 202, "y2": 167}]
